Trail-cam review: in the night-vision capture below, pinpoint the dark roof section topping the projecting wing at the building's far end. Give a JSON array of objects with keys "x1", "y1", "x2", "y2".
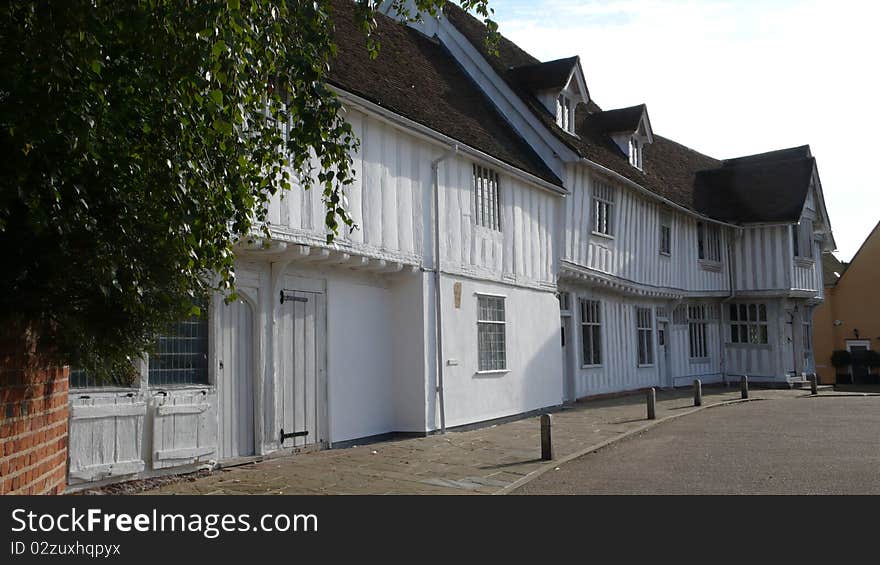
[{"x1": 694, "y1": 152, "x2": 816, "y2": 223}]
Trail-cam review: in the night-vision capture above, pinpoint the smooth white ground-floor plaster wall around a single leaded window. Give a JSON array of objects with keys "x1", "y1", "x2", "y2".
[{"x1": 441, "y1": 275, "x2": 562, "y2": 427}]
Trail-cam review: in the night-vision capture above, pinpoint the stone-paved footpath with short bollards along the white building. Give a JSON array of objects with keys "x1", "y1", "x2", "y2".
[{"x1": 127, "y1": 387, "x2": 825, "y2": 495}]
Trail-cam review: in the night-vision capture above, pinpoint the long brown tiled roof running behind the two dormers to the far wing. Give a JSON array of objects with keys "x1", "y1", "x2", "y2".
[{"x1": 445, "y1": 4, "x2": 814, "y2": 222}]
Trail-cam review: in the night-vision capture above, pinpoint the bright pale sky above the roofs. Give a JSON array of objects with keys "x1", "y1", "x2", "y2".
[{"x1": 489, "y1": 0, "x2": 880, "y2": 261}]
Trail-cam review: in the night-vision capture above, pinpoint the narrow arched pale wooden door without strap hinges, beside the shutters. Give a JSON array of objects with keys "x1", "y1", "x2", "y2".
[{"x1": 217, "y1": 300, "x2": 255, "y2": 459}]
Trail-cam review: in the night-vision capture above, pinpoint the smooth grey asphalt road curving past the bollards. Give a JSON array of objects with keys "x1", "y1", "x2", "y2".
[{"x1": 516, "y1": 396, "x2": 880, "y2": 494}]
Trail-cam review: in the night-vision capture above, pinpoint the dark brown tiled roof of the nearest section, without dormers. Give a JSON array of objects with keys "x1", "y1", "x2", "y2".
[{"x1": 328, "y1": 0, "x2": 562, "y2": 187}]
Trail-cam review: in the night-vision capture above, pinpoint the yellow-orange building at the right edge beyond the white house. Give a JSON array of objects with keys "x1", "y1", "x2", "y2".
[{"x1": 813, "y1": 223, "x2": 880, "y2": 384}]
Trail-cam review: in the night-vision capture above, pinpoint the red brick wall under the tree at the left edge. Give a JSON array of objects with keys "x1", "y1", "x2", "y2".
[{"x1": 0, "y1": 338, "x2": 70, "y2": 494}]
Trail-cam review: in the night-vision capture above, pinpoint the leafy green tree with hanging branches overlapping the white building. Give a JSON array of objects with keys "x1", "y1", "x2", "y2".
[{"x1": 0, "y1": 0, "x2": 496, "y2": 376}]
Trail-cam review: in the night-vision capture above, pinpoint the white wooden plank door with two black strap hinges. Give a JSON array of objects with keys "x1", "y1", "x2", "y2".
[{"x1": 276, "y1": 289, "x2": 327, "y2": 447}]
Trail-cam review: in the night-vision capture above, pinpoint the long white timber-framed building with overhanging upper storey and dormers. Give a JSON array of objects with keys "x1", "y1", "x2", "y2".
[{"x1": 69, "y1": 0, "x2": 834, "y2": 488}]
